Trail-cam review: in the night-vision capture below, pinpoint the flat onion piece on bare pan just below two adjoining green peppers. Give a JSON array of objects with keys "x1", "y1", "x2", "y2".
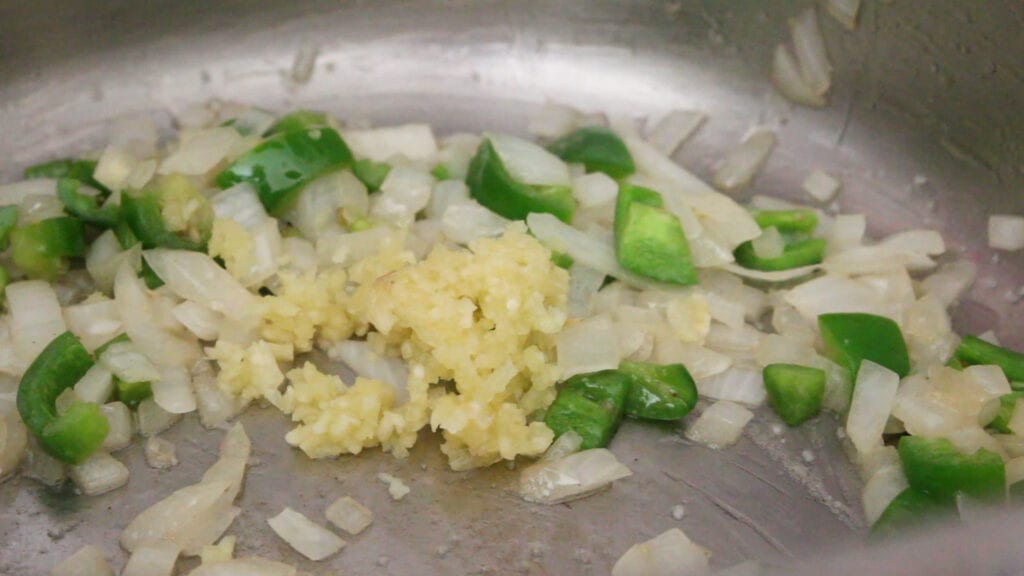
[{"x1": 519, "y1": 448, "x2": 633, "y2": 504}]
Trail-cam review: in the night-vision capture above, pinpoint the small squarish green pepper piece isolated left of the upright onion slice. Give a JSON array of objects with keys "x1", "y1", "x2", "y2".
[{"x1": 763, "y1": 364, "x2": 825, "y2": 426}]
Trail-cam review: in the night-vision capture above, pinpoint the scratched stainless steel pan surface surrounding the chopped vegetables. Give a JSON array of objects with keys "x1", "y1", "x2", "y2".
[{"x1": 0, "y1": 0, "x2": 1024, "y2": 575}]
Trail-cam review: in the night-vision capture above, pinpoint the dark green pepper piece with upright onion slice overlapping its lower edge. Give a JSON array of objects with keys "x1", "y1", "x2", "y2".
[{"x1": 818, "y1": 313, "x2": 910, "y2": 382}]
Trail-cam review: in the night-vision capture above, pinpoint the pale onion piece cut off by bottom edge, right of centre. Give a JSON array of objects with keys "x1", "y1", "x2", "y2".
[{"x1": 611, "y1": 528, "x2": 711, "y2": 576}]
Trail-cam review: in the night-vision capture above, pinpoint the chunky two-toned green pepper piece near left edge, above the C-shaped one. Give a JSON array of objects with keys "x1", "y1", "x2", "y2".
[{"x1": 10, "y1": 216, "x2": 85, "y2": 281}]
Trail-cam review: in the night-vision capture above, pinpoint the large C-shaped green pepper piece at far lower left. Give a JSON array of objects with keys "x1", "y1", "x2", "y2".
[{"x1": 17, "y1": 332, "x2": 110, "y2": 464}]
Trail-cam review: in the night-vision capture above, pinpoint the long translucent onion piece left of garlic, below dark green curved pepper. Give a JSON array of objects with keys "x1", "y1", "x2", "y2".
[{"x1": 143, "y1": 249, "x2": 255, "y2": 320}]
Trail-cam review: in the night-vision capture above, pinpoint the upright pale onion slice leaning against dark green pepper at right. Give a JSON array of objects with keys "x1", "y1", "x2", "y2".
[{"x1": 846, "y1": 360, "x2": 899, "y2": 452}]
